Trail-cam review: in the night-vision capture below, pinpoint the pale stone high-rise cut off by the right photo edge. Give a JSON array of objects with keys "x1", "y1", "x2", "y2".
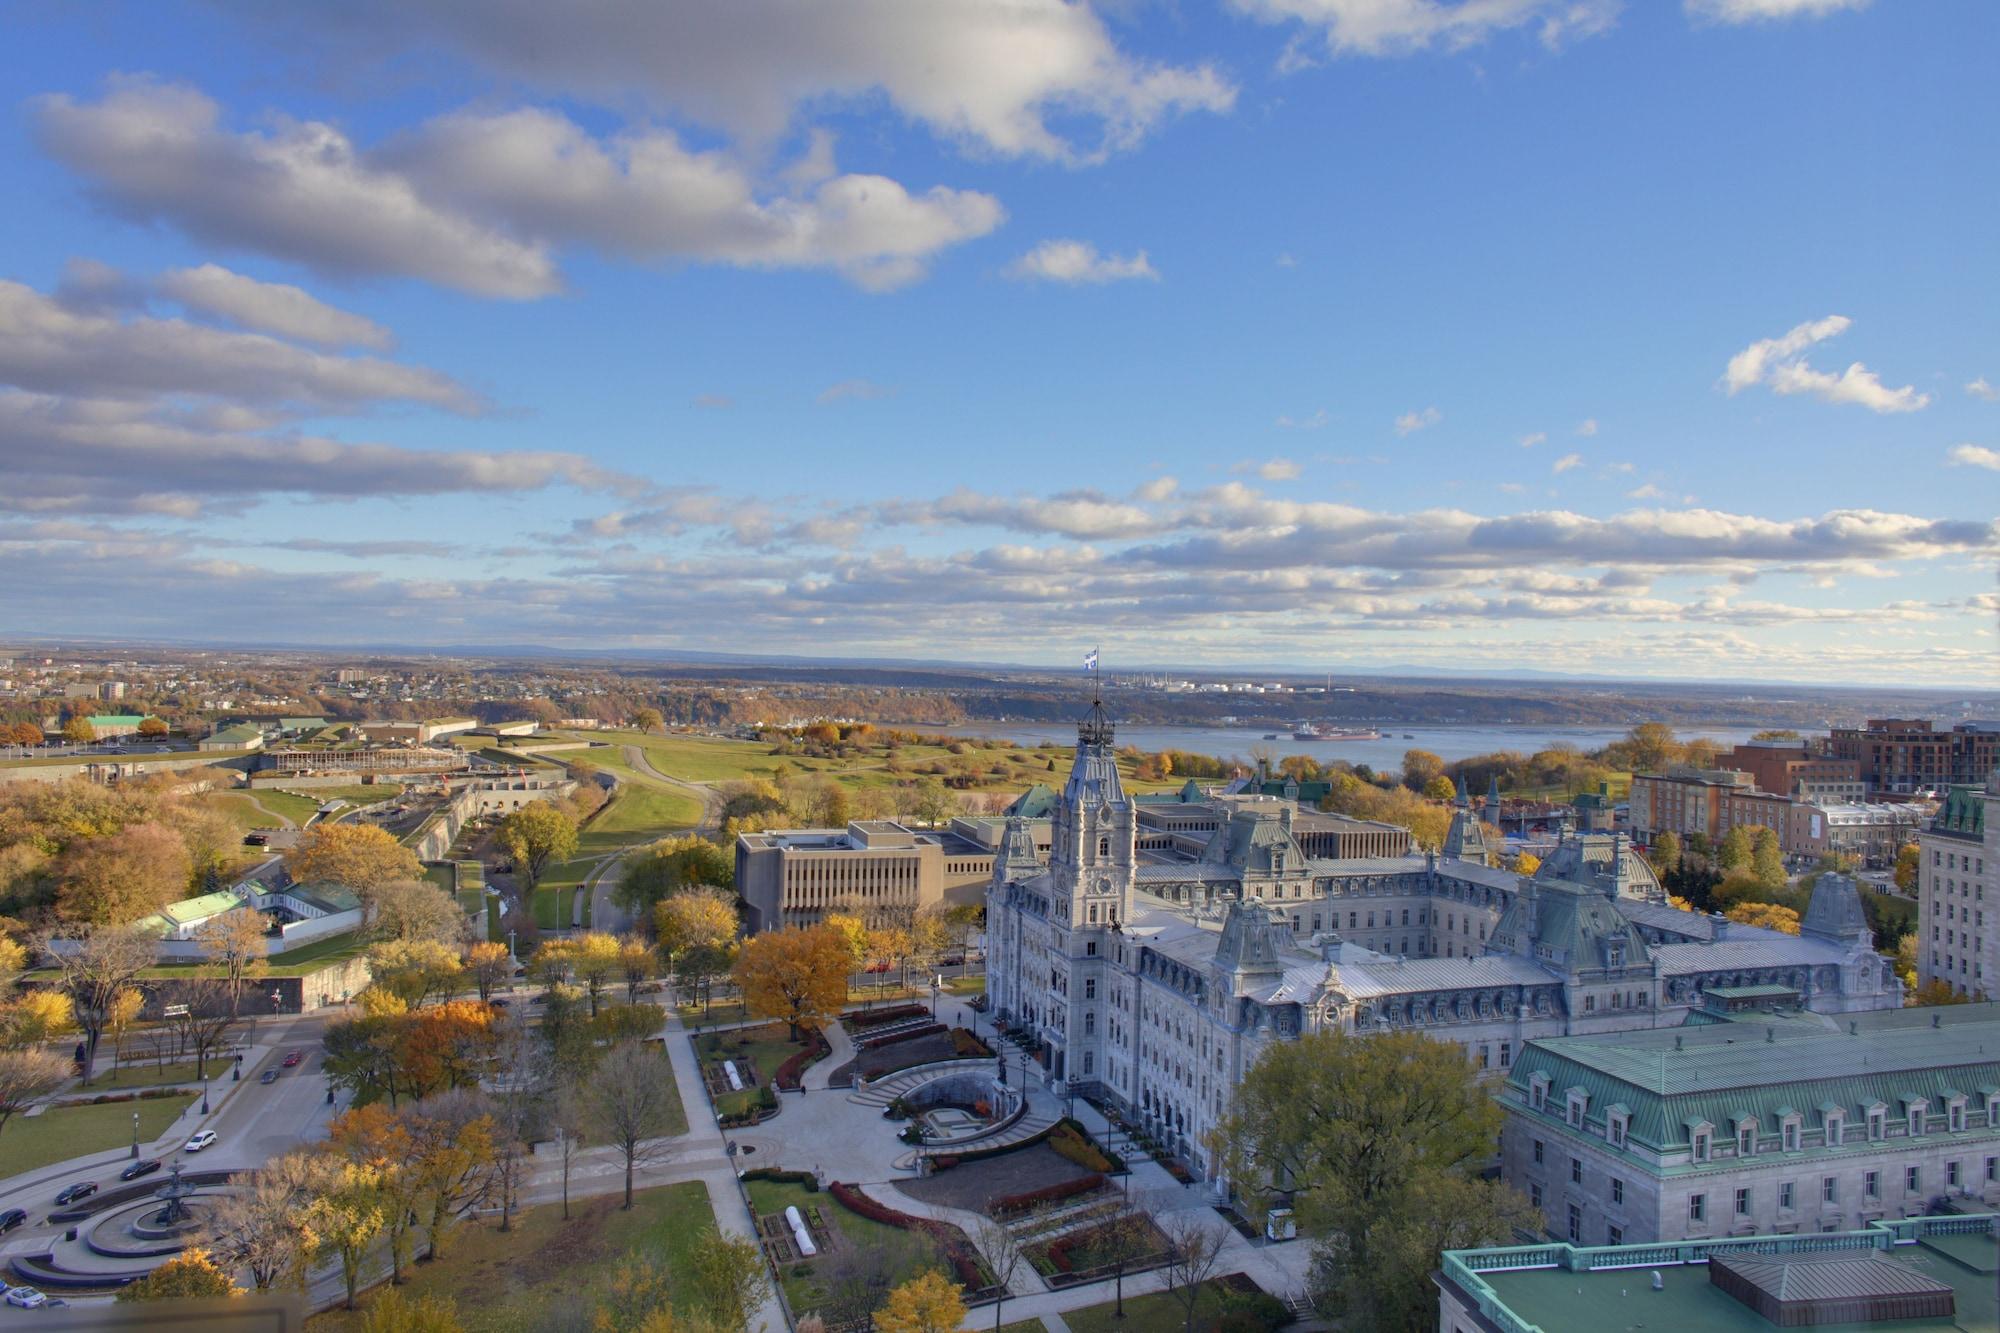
[{"x1": 1916, "y1": 773, "x2": 2000, "y2": 995}]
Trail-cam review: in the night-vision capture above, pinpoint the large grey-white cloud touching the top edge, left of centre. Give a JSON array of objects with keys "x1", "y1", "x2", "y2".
[{"x1": 252, "y1": 0, "x2": 1236, "y2": 162}]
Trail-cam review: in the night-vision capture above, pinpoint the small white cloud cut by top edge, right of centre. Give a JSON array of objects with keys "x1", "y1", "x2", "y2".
[{"x1": 1232, "y1": 0, "x2": 1620, "y2": 57}]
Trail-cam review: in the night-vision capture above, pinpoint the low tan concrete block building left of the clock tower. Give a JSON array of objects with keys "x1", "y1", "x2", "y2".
[{"x1": 736, "y1": 819, "x2": 994, "y2": 933}]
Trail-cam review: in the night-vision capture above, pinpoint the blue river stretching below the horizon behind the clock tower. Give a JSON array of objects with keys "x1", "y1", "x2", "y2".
[{"x1": 924, "y1": 723, "x2": 1756, "y2": 769}]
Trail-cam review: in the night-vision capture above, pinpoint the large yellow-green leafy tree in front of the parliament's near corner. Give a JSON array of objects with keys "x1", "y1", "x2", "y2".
[{"x1": 1216, "y1": 1029, "x2": 1520, "y2": 1327}]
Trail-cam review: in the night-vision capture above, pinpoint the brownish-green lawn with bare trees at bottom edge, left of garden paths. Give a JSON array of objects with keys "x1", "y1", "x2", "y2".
[{"x1": 306, "y1": 1181, "x2": 714, "y2": 1333}]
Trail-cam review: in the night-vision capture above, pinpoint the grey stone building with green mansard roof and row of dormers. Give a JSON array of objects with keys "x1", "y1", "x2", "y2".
[{"x1": 1498, "y1": 996, "x2": 2000, "y2": 1245}]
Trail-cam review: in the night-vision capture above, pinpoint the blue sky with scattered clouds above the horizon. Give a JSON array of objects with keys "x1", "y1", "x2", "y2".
[{"x1": 0, "y1": 0, "x2": 2000, "y2": 685}]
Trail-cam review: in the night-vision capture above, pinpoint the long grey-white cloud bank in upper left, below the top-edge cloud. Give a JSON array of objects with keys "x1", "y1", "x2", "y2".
[{"x1": 36, "y1": 80, "x2": 1006, "y2": 298}]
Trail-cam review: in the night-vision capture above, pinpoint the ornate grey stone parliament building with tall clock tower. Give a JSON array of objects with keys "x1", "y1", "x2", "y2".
[{"x1": 986, "y1": 703, "x2": 1902, "y2": 1179}]
